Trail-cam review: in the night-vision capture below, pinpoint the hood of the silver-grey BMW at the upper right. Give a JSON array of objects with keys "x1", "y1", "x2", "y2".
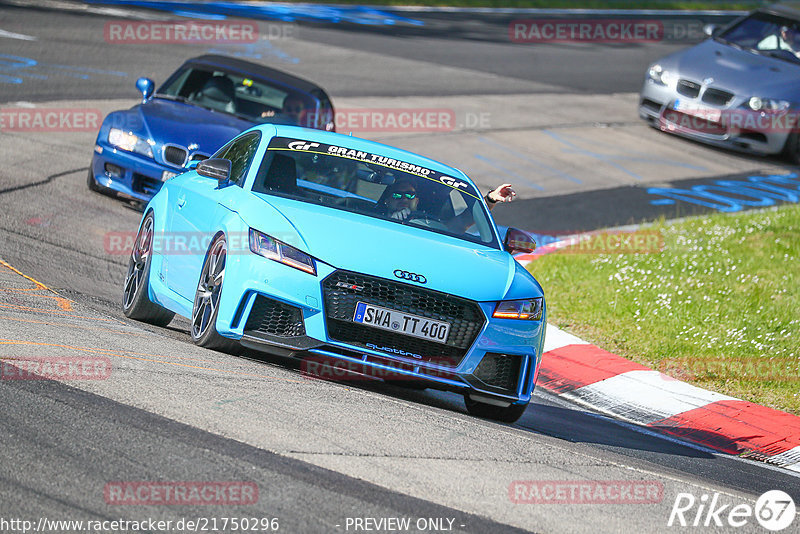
[{"x1": 658, "y1": 39, "x2": 800, "y2": 98}]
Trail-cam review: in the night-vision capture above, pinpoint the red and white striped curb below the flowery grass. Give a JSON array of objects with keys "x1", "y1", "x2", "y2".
[{"x1": 537, "y1": 324, "x2": 800, "y2": 472}]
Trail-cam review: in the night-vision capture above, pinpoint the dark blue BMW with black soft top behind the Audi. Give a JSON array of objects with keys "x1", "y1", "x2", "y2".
[{"x1": 88, "y1": 55, "x2": 334, "y2": 201}]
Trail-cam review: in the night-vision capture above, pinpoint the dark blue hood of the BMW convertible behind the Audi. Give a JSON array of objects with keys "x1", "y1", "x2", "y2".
[{"x1": 132, "y1": 98, "x2": 253, "y2": 154}]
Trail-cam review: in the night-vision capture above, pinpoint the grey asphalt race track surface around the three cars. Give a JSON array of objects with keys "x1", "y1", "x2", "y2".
[{"x1": 0, "y1": 2, "x2": 800, "y2": 533}]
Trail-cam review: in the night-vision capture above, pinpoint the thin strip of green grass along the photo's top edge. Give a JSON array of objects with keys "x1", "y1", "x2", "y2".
[{"x1": 312, "y1": 0, "x2": 774, "y2": 10}]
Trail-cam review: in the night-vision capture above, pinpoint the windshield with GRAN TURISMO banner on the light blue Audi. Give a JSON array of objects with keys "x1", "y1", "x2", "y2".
[{"x1": 253, "y1": 137, "x2": 500, "y2": 248}]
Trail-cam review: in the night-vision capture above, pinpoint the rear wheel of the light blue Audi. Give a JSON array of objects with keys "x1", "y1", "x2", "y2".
[{"x1": 122, "y1": 211, "x2": 175, "y2": 326}]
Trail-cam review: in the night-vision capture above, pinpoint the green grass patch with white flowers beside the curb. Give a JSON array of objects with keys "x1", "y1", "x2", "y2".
[{"x1": 529, "y1": 205, "x2": 800, "y2": 415}]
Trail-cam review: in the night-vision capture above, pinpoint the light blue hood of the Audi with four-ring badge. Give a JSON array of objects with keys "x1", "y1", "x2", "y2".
[{"x1": 248, "y1": 194, "x2": 542, "y2": 301}]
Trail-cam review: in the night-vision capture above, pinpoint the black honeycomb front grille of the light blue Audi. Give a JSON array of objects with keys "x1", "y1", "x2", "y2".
[{"x1": 322, "y1": 271, "x2": 485, "y2": 366}]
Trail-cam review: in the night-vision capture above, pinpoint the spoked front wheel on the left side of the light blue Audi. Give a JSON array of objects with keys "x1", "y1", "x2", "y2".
[{"x1": 191, "y1": 235, "x2": 241, "y2": 352}]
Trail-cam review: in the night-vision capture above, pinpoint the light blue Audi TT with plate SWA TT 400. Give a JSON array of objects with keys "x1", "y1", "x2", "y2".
[{"x1": 123, "y1": 124, "x2": 546, "y2": 422}]
